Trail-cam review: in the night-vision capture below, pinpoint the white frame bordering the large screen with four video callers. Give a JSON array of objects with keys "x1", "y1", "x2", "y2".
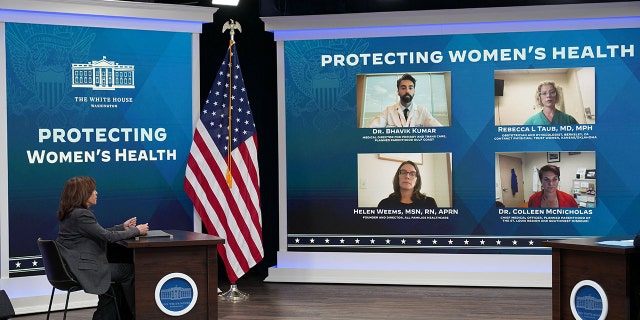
[{"x1": 262, "y1": 3, "x2": 640, "y2": 287}]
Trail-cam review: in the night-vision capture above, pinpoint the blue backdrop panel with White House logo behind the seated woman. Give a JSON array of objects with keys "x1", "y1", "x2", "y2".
[{"x1": 6, "y1": 23, "x2": 193, "y2": 276}]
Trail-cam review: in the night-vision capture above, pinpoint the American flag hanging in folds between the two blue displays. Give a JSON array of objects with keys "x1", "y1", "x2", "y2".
[{"x1": 184, "y1": 40, "x2": 264, "y2": 283}]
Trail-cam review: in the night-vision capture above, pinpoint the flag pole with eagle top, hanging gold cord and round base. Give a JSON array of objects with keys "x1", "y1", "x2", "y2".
[{"x1": 218, "y1": 19, "x2": 249, "y2": 302}]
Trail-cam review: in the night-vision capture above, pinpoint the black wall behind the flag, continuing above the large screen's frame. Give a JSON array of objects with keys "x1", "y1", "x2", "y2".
[{"x1": 129, "y1": 0, "x2": 631, "y2": 276}]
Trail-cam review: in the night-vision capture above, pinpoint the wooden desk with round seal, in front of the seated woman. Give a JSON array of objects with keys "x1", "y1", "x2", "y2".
[{"x1": 119, "y1": 230, "x2": 224, "y2": 320}]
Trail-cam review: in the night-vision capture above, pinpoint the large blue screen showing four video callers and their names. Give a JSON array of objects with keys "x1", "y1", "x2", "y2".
[{"x1": 284, "y1": 29, "x2": 640, "y2": 254}]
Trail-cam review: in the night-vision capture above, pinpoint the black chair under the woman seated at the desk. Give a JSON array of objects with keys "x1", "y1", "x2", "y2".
[{"x1": 38, "y1": 238, "x2": 120, "y2": 320}]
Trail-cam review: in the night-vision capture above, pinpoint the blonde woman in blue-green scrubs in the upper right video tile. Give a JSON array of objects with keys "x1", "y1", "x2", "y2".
[{"x1": 524, "y1": 81, "x2": 578, "y2": 125}]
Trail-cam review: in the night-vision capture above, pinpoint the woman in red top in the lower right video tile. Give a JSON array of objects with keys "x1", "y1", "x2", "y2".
[{"x1": 529, "y1": 164, "x2": 578, "y2": 208}]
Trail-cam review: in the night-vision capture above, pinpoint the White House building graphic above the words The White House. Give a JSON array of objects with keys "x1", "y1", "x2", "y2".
[{"x1": 71, "y1": 56, "x2": 135, "y2": 90}]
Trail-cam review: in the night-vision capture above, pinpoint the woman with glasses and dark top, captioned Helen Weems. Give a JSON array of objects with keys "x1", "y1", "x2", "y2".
[{"x1": 378, "y1": 160, "x2": 438, "y2": 209}]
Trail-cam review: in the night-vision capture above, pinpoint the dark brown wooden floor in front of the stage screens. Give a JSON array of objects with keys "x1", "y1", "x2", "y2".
[{"x1": 13, "y1": 277, "x2": 551, "y2": 320}]
